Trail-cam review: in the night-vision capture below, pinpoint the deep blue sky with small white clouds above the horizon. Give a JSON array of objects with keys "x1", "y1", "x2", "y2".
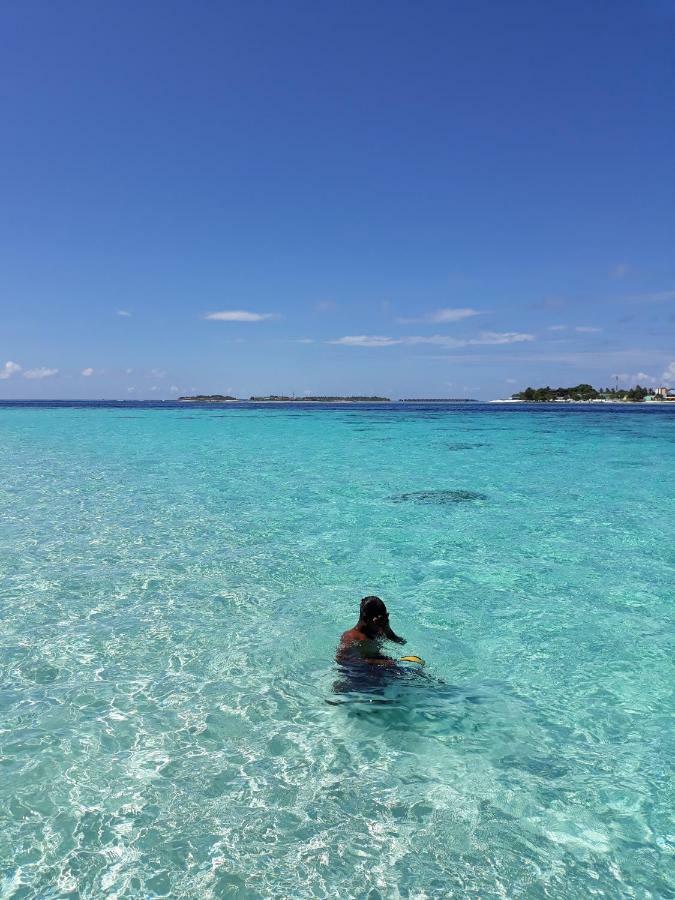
[{"x1": 0, "y1": 0, "x2": 675, "y2": 399}]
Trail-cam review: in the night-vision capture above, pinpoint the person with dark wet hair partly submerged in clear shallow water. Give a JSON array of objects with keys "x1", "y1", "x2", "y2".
[{"x1": 333, "y1": 597, "x2": 405, "y2": 694}]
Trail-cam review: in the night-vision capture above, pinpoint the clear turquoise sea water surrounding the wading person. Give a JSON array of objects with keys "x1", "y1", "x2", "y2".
[{"x1": 0, "y1": 403, "x2": 675, "y2": 900}]
